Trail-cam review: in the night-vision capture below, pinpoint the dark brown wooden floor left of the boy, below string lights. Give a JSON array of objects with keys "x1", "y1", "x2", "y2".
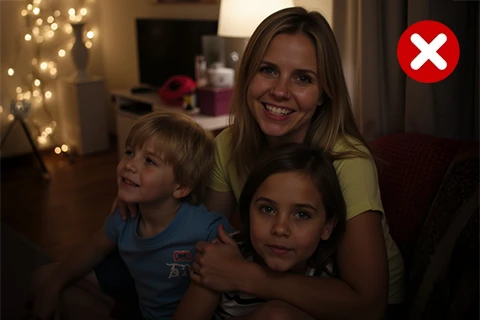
[{"x1": 0, "y1": 141, "x2": 117, "y2": 260}]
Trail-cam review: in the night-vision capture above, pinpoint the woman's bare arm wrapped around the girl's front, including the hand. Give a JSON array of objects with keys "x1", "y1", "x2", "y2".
[{"x1": 192, "y1": 211, "x2": 388, "y2": 319}]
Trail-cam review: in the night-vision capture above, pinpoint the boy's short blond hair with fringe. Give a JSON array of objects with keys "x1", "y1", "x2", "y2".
[{"x1": 125, "y1": 111, "x2": 215, "y2": 204}]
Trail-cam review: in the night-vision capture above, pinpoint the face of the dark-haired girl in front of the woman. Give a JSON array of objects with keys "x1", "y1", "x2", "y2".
[{"x1": 250, "y1": 172, "x2": 333, "y2": 272}]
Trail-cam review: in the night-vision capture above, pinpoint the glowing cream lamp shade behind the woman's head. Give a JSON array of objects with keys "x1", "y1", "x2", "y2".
[{"x1": 218, "y1": 0, "x2": 293, "y2": 38}]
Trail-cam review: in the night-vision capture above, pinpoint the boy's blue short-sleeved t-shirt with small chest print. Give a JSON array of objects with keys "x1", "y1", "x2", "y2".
[{"x1": 104, "y1": 202, "x2": 233, "y2": 319}]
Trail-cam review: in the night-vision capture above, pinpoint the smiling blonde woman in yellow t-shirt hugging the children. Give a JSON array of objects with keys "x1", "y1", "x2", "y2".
[{"x1": 117, "y1": 7, "x2": 404, "y2": 319}]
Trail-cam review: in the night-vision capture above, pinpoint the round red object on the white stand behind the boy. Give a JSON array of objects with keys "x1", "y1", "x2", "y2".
[{"x1": 158, "y1": 75, "x2": 196, "y2": 106}]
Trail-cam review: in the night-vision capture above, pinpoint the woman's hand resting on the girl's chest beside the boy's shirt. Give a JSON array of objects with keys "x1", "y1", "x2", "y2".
[{"x1": 190, "y1": 225, "x2": 249, "y2": 292}]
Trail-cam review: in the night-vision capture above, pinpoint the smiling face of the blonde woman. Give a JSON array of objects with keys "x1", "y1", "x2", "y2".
[{"x1": 247, "y1": 33, "x2": 320, "y2": 143}]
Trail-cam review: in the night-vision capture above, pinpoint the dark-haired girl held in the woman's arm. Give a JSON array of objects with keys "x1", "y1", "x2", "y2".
[{"x1": 173, "y1": 144, "x2": 346, "y2": 320}]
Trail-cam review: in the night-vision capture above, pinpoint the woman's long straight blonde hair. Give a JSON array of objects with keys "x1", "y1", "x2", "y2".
[{"x1": 230, "y1": 7, "x2": 370, "y2": 178}]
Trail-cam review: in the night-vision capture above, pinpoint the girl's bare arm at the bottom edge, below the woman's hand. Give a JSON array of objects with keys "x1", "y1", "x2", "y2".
[{"x1": 172, "y1": 282, "x2": 221, "y2": 320}]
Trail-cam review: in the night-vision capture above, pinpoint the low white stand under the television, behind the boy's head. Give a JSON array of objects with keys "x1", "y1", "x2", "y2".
[{"x1": 111, "y1": 90, "x2": 229, "y2": 158}]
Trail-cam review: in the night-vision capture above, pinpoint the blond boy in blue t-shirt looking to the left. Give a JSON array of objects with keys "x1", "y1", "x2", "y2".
[{"x1": 32, "y1": 112, "x2": 231, "y2": 319}]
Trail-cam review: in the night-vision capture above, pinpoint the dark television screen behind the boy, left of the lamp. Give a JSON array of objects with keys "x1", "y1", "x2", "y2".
[{"x1": 136, "y1": 19, "x2": 218, "y2": 87}]
